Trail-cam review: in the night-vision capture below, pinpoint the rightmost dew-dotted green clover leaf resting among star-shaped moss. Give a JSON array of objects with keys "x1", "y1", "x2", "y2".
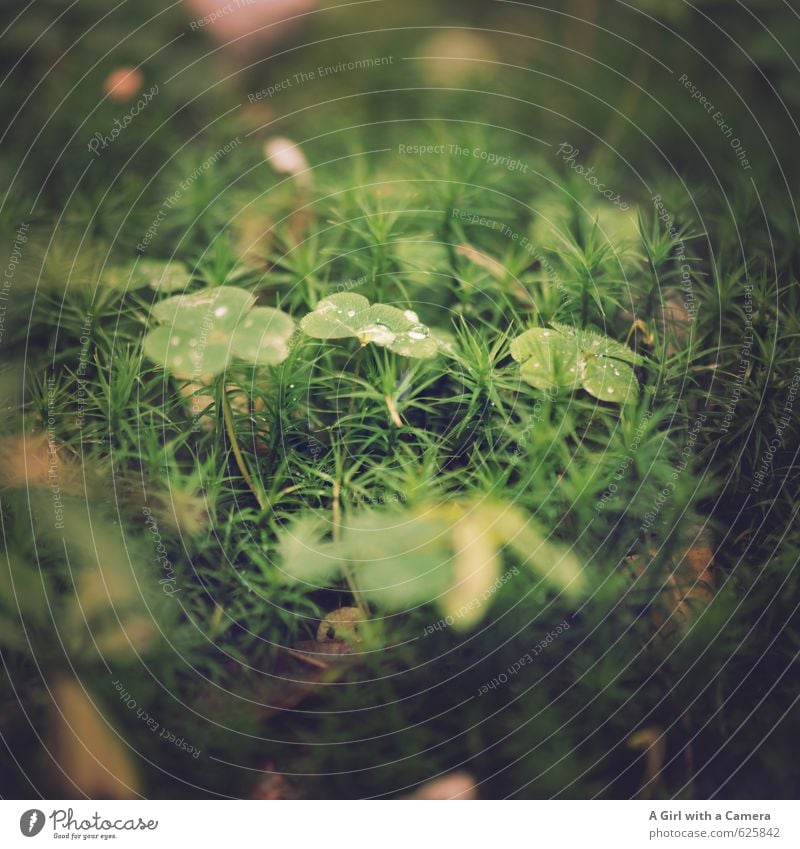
[{"x1": 511, "y1": 322, "x2": 644, "y2": 404}]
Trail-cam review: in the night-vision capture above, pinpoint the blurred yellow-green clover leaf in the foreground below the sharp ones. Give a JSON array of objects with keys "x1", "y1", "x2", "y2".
[{"x1": 278, "y1": 500, "x2": 586, "y2": 630}]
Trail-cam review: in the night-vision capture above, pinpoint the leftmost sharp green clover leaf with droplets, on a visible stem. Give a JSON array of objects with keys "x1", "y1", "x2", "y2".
[{"x1": 143, "y1": 286, "x2": 295, "y2": 381}]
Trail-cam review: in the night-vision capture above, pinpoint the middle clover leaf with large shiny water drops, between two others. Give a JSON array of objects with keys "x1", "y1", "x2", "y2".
[{"x1": 300, "y1": 292, "x2": 443, "y2": 359}]
